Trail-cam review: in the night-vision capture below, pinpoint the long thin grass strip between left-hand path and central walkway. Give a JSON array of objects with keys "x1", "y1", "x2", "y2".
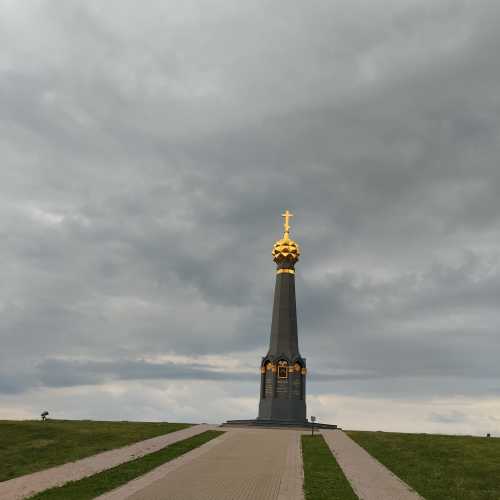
[{"x1": 30, "y1": 431, "x2": 223, "y2": 500}]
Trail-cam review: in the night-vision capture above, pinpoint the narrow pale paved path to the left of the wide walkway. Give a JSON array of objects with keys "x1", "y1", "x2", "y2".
[{"x1": 0, "y1": 424, "x2": 217, "y2": 500}]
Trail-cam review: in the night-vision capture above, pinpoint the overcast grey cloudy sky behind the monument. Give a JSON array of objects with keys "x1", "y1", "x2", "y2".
[{"x1": 0, "y1": 0, "x2": 500, "y2": 434}]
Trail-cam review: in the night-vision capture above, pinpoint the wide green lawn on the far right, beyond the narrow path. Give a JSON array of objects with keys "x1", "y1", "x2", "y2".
[{"x1": 348, "y1": 431, "x2": 500, "y2": 500}]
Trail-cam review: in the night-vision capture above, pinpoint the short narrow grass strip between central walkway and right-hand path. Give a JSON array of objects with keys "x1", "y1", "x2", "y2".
[{"x1": 302, "y1": 436, "x2": 358, "y2": 500}]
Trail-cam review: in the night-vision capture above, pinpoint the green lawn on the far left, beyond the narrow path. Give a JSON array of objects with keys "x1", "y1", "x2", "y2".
[{"x1": 0, "y1": 420, "x2": 190, "y2": 481}]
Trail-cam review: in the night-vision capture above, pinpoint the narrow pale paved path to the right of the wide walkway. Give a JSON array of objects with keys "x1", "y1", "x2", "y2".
[{"x1": 321, "y1": 430, "x2": 422, "y2": 500}]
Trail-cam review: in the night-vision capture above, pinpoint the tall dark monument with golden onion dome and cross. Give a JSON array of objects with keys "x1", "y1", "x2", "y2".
[{"x1": 257, "y1": 210, "x2": 307, "y2": 424}]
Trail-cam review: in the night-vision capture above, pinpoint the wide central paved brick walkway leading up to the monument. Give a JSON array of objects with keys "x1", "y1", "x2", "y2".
[{"x1": 98, "y1": 429, "x2": 304, "y2": 500}]
